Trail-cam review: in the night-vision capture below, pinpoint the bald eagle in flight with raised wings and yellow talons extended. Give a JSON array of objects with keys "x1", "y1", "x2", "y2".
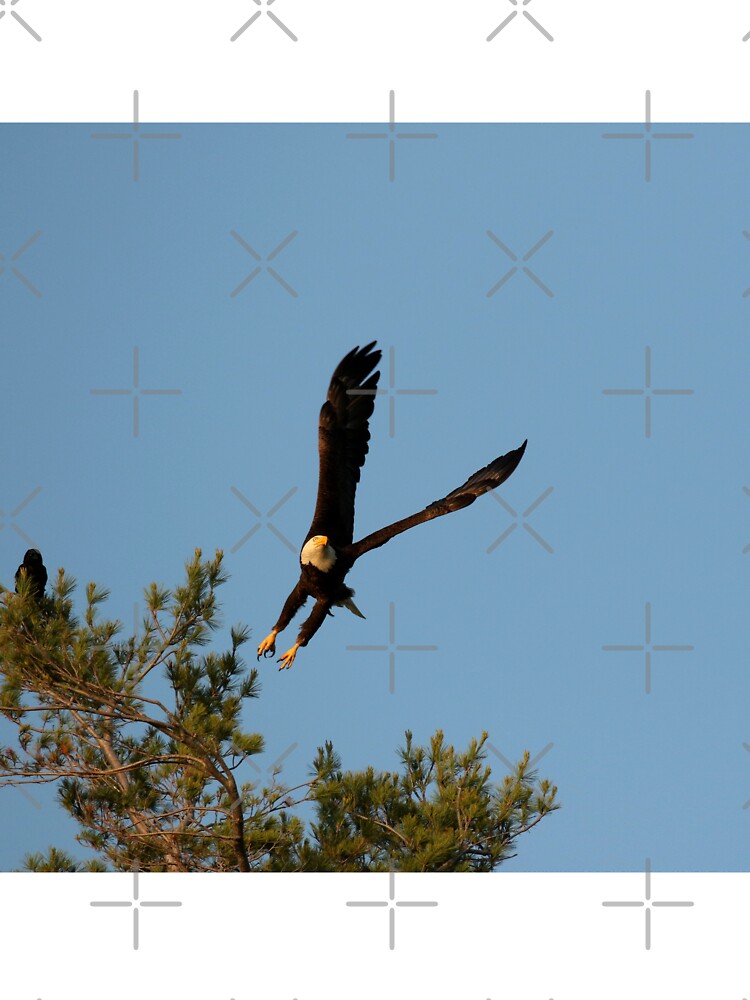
[{"x1": 258, "y1": 341, "x2": 526, "y2": 670}]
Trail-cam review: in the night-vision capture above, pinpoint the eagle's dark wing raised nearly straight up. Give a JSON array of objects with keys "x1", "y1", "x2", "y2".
[{"x1": 305, "y1": 340, "x2": 382, "y2": 547}]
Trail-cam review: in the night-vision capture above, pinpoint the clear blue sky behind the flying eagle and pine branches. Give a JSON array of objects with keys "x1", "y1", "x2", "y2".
[{"x1": 0, "y1": 124, "x2": 750, "y2": 871}]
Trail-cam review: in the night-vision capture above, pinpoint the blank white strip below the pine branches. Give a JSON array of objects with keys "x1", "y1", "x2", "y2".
[{"x1": 0, "y1": 872, "x2": 750, "y2": 1000}]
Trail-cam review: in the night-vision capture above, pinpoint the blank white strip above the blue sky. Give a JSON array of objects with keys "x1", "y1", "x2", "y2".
[{"x1": 0, "y1": 0, "x2": 750, "y2": 122}]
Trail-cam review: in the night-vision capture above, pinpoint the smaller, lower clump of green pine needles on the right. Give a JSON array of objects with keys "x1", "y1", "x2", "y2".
[{"x1": 282, "y1": 730, "x2": 558, "y2": 872}]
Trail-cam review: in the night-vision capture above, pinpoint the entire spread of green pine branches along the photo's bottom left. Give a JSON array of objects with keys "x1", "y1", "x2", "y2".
[{"x1": 0, "y1": 550, "x2": 557, "y2": 871}]
